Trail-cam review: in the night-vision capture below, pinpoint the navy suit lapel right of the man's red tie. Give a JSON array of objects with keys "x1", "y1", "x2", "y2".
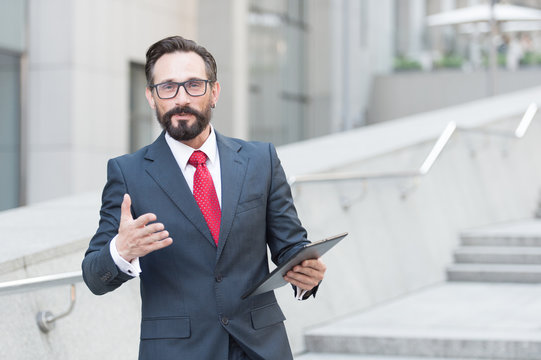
[{"x1": 216, "y1": 132, "x2": 248, "y2": 260}]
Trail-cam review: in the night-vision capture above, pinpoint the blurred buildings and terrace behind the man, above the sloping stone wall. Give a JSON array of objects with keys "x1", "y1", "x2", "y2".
[{"x1": 0, "y1": 0, "x2": 541, "y2": 209}]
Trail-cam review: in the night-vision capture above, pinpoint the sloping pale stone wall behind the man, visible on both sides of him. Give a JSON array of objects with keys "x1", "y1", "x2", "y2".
[{"x1": 0, "y1": 88, "x2": 541, "y2": 360}]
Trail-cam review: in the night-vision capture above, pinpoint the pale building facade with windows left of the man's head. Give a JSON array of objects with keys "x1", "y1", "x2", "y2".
[{"x1": 0, "y1": 0, "x2": 197, "y2": 209}]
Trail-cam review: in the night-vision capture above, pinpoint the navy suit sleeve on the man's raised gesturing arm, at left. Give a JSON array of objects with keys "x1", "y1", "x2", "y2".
[{"x1": 82, "y1": 159, "x2": 132, "y2": 295}]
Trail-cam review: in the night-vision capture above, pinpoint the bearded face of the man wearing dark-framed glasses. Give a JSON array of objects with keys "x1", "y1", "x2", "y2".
[{"x1": 146, "y1": 52, "x2": 220, "y2": 141}]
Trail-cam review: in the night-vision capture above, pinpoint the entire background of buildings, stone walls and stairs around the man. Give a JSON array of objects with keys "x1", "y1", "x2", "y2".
[{"x1": 0, "y1": 0, "x2": 541, "y2": 360}]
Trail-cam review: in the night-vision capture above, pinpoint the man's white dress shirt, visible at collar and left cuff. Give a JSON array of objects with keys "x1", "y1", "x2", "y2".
[{"x1": 109, "y1": 125, "x2": 222, "y2": 276}]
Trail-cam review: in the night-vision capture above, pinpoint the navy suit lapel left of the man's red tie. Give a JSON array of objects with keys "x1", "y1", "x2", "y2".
[{"x1": 145, "y1": 132, "x2": 217, "y2": 246}]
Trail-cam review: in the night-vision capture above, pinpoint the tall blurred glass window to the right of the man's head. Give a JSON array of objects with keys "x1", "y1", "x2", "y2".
[{"x1": 249, "y1": 0, "x2": 308, "y2": 145}]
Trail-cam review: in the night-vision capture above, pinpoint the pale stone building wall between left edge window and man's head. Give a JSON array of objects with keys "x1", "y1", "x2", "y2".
[{"x1": 22, "y1": 0, "x2": 197, "y2": 204}]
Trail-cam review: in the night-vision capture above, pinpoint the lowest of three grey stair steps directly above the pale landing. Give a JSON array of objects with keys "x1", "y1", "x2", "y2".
[{"x1": 447, "y1": 264, "x2": 541, "y2": 283}]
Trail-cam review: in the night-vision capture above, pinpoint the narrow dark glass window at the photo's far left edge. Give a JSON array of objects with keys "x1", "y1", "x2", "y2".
[{"x1": 0, "y1": 50, "x2": 21, "y2": 210}]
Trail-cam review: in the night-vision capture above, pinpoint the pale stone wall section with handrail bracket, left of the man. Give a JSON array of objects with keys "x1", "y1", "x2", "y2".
[{"x1": 0, "y1": 192, "x2": 141, "y2": 360}]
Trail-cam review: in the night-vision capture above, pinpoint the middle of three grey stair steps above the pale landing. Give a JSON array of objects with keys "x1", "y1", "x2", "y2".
[{"x1": 454, "y1": 246, "x2": 541, "y2": 265}]
